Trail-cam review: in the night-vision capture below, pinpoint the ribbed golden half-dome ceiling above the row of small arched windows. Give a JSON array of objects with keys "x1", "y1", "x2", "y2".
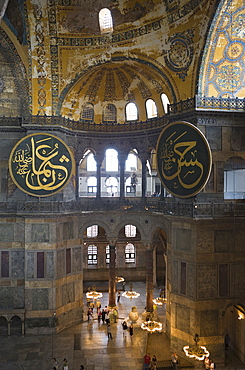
[{"x1": 62, "y1": 61, "x2": 171, "y2": 119}]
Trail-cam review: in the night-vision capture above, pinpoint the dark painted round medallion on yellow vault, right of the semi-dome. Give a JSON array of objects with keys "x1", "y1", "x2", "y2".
[{"x1": 165, "y1": 31, "x2": 193, "y2": 81}]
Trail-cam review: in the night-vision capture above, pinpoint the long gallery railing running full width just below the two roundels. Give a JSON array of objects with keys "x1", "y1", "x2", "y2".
[{"x1": 0, "y1": 198, "x2": 245, "y2": 218}]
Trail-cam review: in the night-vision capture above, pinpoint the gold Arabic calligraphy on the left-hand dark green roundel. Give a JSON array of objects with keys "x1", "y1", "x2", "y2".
[{"x1": 12, "y1": 137, "x2": 70, "y2": 191}]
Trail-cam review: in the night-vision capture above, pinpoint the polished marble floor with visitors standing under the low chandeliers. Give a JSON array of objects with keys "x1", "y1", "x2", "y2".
[{"x1": 0, "y1": 283, "x2": 244, "y2": 370}]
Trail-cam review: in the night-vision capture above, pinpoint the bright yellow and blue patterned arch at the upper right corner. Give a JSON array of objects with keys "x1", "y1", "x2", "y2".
[{"x1": 198, "y1": 0, "x2": 245, "y2": 98}]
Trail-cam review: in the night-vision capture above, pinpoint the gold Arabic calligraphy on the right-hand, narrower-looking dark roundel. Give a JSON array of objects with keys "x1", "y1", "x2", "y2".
[{"x1": 161, "y1": 131, "x2": 203, "y2": 189}]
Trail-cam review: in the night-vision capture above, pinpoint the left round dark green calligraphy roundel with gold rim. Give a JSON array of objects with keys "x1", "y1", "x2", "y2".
[{"x1": 9, "y1": 133, "x2": 74, "y2": 197}]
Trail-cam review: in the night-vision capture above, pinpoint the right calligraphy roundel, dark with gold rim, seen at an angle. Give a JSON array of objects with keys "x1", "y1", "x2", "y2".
[{"x1": 157, "y1": 122, "x2": 212, "y2": 198}]
